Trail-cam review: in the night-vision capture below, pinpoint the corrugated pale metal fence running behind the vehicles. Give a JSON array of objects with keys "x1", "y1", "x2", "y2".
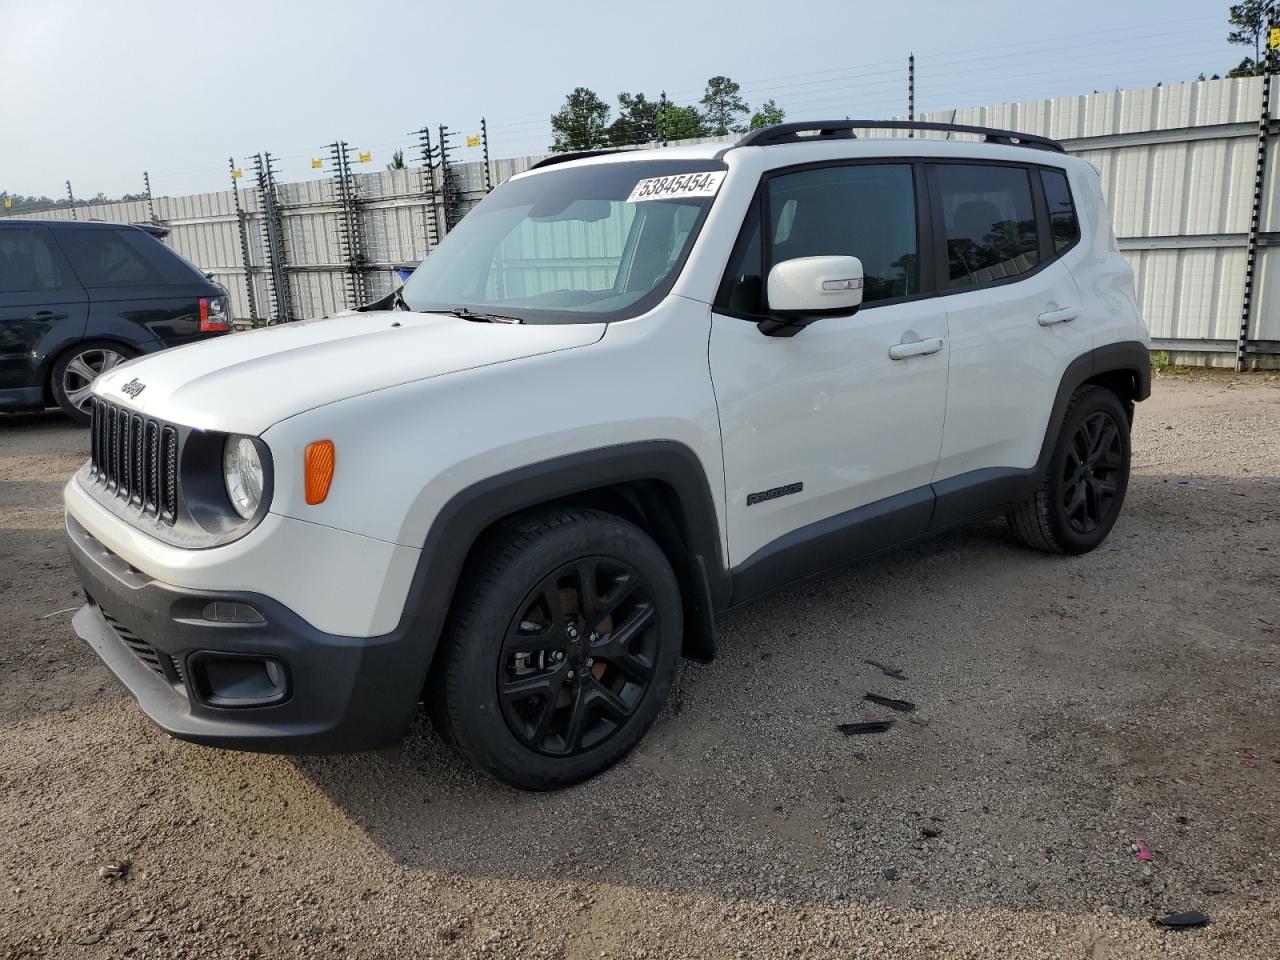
[{"x1": 12, "y1": 77, "x2": 1280, "y2": 367}]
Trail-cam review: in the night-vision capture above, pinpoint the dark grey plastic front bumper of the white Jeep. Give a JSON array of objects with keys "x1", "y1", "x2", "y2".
[{"x1": 67, "y1": 515, "x2": 433, "y2": 754}]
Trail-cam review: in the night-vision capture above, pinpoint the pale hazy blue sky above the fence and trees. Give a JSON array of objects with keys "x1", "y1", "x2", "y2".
[{"x1": 0, "y1": 0, "x2": 1244, "y2": 197}]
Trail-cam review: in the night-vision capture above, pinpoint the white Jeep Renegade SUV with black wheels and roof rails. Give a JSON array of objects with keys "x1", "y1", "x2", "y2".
[{"x1": 65, "y1": 122, "x2": 1149, "y2": 788}]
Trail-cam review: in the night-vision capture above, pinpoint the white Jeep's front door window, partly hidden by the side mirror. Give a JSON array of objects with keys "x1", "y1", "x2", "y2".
[{"x1": 768, "y1": 164, "x2": 920, "y2": 303}]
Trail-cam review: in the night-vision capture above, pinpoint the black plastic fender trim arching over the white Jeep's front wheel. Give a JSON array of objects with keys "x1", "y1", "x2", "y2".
[{"x1": 397, "y1": 440, "x2": 730, "y2": 659}]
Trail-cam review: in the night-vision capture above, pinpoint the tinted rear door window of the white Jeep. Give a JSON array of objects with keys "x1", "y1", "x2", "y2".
[{"x1": 933, "y1": 164, "x2": 1039, "y2": 287}]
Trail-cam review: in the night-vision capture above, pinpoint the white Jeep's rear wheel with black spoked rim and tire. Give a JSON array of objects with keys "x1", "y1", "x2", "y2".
[{"x1": 1006, "y1": 385, "x2": 1132, "y2": 554}]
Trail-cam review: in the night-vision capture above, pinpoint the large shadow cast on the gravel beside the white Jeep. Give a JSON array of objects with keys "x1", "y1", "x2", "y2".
[{"x1": 296, "y1": 476, "x2": 1280, "y2": 915}]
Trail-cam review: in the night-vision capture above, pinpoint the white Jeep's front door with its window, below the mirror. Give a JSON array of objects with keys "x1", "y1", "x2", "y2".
[{"x1": 710, "y1": 163, "x2": 947, "y2": 600}]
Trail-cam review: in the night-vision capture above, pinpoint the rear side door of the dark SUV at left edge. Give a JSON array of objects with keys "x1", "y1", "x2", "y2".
[{"x1": 0, "y1": 224, "x2": 88, "y2": 406}]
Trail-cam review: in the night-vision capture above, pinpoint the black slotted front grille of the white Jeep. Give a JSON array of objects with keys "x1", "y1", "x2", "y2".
[{"x1": 91, "y1": 397, "x2": 178, "y2": 524}]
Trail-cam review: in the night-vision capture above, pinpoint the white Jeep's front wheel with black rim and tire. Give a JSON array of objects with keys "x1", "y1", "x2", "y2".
[{"x1": 429, "y1": 509, "x2": 684, "y2": 790}]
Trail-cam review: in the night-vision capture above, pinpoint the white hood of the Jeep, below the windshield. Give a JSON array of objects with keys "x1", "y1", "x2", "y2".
[{"x1": 93, "y1": 310, "x2": 605, "y2": 434}]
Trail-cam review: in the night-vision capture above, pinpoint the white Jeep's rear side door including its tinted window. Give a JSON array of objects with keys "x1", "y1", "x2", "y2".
[{"x1": 929, "y1": 161, "x2": 1093, "y2": 512}]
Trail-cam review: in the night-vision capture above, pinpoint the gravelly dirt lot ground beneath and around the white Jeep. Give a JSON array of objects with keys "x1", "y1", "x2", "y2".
[{"x1": 0, "y1": 376, "x2": 1280, "y2": 960}]
